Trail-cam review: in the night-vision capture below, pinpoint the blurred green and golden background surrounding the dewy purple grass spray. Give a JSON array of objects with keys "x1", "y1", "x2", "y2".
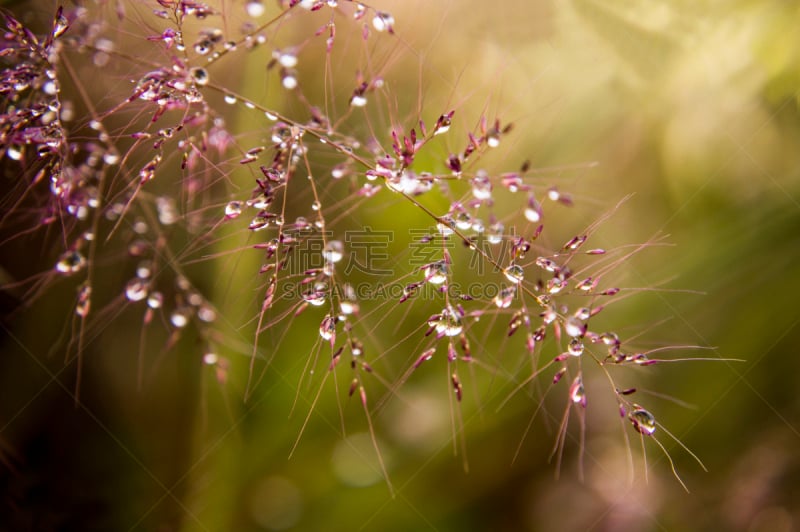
[{"x1": 0, "y1": 0, "x2": 800, "y2": 531}]
